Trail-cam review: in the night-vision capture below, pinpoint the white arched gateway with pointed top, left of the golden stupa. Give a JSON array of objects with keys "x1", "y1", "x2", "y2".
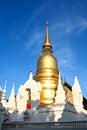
[{"x1": 11, "y1": 73, "x2": 42, "y2": 121}]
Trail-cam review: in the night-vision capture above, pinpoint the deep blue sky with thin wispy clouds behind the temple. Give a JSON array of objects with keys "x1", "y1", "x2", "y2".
[{"x1": 0, "y1": 0, "x2": 87, "y2": 98}]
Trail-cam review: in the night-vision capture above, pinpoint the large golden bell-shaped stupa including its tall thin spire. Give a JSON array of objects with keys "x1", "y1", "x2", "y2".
[{"x1": 34, "y1": 22, "x2": 59, "y2": 107}]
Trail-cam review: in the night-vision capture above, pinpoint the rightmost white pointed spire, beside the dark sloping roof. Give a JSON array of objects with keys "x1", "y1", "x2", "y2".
[{"x1": 72, "y1": 76, "x2": 83, "y2": 110}]
